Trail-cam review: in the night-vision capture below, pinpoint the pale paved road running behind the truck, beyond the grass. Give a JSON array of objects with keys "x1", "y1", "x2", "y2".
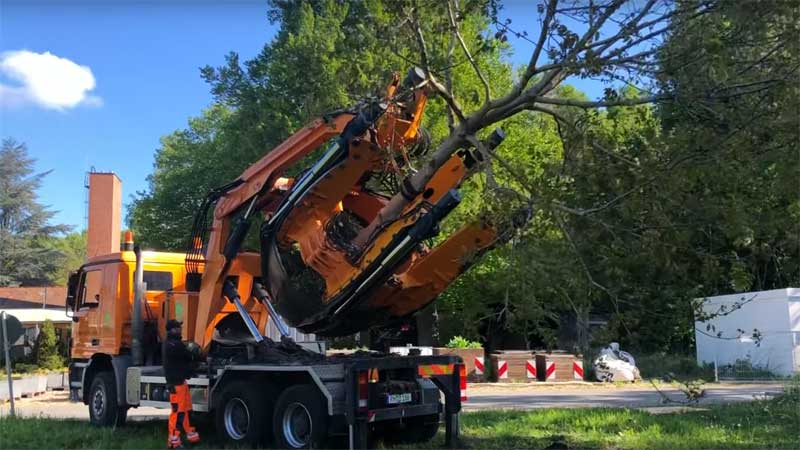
[{"x1": 0, "y1": 384, "x2": 783, "y2": 420}]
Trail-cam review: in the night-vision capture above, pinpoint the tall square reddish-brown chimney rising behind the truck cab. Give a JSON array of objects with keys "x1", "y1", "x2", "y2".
[{"x1": 86, "y1": 172, "x2": 122, "y2": 258}]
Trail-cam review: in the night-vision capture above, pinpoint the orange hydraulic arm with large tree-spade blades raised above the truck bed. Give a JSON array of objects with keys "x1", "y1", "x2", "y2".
[{"x1": 187, "y1": 69, "x2": 520, "y2": 346}]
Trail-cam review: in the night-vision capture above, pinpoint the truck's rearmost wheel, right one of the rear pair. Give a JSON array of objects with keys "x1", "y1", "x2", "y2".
[{"x1": 272, "y1": 384, "x2": 328, "y2": 449}]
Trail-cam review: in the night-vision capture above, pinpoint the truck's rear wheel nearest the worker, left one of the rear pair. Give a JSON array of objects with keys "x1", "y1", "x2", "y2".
[{"x1": 216, "y1": 381, "x2": 272, "y2": 447}]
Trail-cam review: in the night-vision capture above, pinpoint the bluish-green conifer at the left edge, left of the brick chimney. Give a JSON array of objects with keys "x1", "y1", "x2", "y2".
[{"x1": 0, "y1": 139, "x2": 69, "y2": 286}]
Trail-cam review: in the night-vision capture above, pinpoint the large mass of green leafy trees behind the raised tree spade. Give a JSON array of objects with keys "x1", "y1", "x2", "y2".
[{"x1": 129, "y1": 0, "x2": 800, "y2": 351}]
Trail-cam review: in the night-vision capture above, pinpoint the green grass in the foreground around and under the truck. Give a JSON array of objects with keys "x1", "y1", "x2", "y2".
[{"x1": 0, "y1": 391, "x2": 800, "y2": 450}]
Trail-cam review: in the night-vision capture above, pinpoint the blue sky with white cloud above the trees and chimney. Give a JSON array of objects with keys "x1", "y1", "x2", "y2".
[{"x1": 0, "y1": 0, "x2": 602, "y2": 230}]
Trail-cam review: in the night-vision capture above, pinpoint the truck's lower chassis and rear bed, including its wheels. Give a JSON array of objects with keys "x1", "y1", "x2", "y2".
[{"x1": 70, "y1": 355, "x2": 466, "y2": 449}]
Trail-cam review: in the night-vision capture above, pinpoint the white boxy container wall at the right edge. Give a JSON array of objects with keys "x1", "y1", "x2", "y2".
[{"x1": 695, "y1": 288, "x2": 800, "y2": 376}]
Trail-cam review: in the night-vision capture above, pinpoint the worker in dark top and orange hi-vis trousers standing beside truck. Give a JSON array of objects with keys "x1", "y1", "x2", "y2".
[{"x1": 163, "y1": 320, "x2": 200, "y2": 448}]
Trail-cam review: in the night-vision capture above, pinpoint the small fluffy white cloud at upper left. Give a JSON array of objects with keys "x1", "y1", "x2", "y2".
[{"x1": 0, "y1": 50, "x2": 102, "y2": 111}]
